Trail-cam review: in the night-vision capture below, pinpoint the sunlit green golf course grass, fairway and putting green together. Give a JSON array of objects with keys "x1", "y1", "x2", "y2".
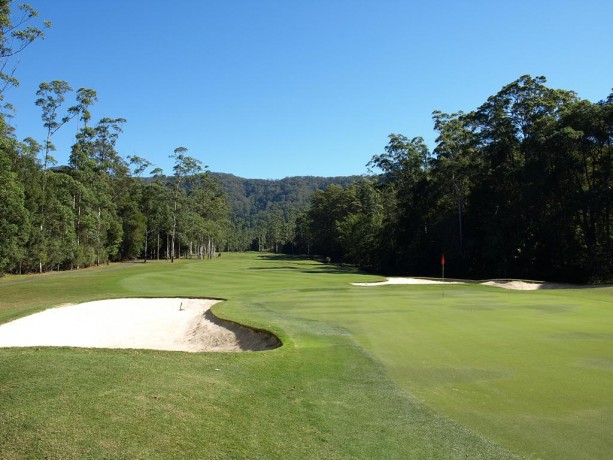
[{"x1": 0, "y1": 254, "x2": 613, "y2": 459}]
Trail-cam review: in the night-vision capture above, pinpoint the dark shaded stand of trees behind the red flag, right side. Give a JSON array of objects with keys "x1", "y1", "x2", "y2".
[{"x1": 302, "y1": 76, "x2": 613, "y2": 282}]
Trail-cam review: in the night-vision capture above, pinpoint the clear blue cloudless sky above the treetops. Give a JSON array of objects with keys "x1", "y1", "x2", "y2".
[{"x1": 6, "y1": 0, "x2": 613, "y2": 179}]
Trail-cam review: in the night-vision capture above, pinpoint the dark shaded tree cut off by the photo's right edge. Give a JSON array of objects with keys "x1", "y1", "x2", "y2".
[{"x1": 544, "y1": 95, "x2": 613, "y2": 281}]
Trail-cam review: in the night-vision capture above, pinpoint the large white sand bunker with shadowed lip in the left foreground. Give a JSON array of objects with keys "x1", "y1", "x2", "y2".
[{"x1": 0, "y1": 298, "x2": 281, "y2": 352}]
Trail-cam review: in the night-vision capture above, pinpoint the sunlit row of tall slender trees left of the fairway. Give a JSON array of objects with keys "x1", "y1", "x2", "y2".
[{"x1": 0, "y1": 0, "x2": 230, "y2": 275}]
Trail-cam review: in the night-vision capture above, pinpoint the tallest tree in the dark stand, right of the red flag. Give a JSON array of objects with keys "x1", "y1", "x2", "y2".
[{"x1": 467, "y1": 75, "x2": 576, "y2": 277}]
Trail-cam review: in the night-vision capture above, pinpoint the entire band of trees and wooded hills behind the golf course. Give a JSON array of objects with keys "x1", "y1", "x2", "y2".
[{"x1": 0, "y1": 0, "x2": 613, "y2": 282}]
